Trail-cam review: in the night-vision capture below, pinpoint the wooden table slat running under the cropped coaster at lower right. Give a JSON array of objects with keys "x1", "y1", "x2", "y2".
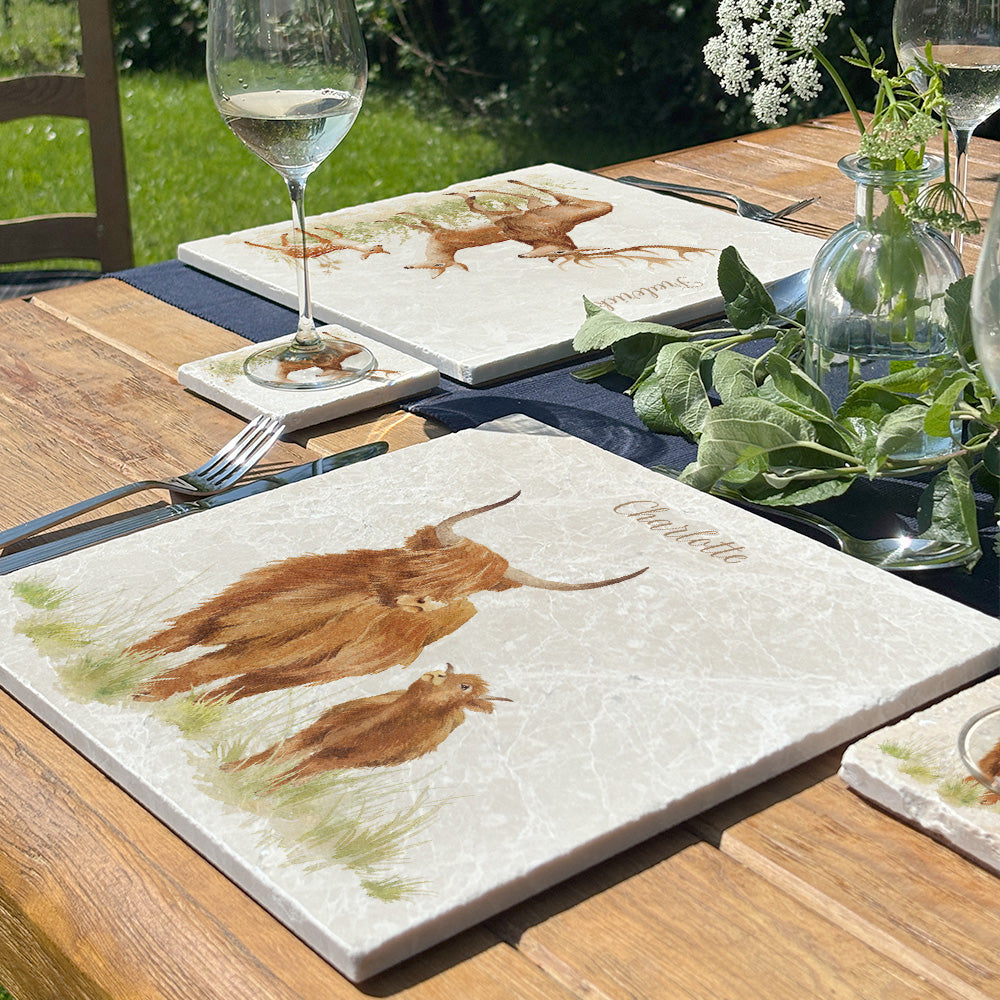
[{"x1": 693, "y1": 756, "x2": 1000, "y2": 1000}]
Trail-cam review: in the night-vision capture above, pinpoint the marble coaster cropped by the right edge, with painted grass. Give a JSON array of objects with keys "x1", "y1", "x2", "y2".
[{"x1": 840, "y1": 677, "x2": 1000, "y2": 874}]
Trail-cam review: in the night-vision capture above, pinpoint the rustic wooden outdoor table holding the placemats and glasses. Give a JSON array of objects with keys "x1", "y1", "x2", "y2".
[{"x1": 0, "y1": 116, "x2": 1000, "y2": 1000}]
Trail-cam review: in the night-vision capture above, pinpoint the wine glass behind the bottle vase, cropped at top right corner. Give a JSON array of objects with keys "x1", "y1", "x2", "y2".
[{"x1": 892, "y1": 0, "x2": 1000, "y2": 207}]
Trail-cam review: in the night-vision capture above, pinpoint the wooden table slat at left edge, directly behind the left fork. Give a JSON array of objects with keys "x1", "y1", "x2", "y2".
[{"x1": 0, "y1": 296, "x2": 318, "y2": 527}]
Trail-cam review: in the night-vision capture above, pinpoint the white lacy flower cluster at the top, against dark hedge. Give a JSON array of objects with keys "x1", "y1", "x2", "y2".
[{"x1": 705, "y1": 0, "x2": 844, "y2": 125}]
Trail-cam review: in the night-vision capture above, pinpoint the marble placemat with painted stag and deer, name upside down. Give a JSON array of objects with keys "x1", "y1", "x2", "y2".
[{"x1": 177, "y1": 164, "x2": 822, "y2": 384}]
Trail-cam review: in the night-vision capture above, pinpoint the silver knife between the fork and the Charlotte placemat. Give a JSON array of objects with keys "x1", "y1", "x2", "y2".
[{"x1": 0, "y1": 441, "x2": 389, "y2": 576}]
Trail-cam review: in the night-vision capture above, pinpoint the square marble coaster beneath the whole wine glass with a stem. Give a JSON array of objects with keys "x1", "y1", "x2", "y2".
[{"x1": 177, "y1": 325, "x2": 440, "y2": 431}]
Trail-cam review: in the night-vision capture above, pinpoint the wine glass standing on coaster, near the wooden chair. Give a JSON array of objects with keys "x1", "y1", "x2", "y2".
[{"x1": 207, "y1": 0, "x2": 375, "y2": 389}]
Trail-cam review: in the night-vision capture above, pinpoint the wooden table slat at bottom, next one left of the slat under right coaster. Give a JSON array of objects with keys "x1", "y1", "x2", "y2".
[{"x1": 489, "y1": 831, "x2": 951, "y2": 1000}]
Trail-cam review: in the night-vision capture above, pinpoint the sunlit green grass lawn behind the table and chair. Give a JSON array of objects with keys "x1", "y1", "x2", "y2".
[{"x1": 0, "y1": 73, "x2": 638, "y2": 264}]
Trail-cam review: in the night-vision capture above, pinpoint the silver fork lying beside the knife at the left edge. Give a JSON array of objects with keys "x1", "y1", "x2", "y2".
[{"x1": 0, "y1": 415, "x2": 285, "y2": 548}]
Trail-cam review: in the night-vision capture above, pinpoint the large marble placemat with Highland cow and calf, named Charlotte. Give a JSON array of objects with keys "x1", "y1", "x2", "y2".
[{"x1": 0, "y1": 421, "x2": 1000, "y2": 978}]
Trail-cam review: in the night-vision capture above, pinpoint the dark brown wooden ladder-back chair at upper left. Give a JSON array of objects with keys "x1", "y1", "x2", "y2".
[{"x1": 0, "y1": 0, "x2": 133, "y2": 299}]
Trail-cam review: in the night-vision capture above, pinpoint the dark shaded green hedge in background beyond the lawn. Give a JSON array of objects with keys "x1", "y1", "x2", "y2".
[{"x1": 105, "y1": 0, "x2": 891, "y2": 148}]
